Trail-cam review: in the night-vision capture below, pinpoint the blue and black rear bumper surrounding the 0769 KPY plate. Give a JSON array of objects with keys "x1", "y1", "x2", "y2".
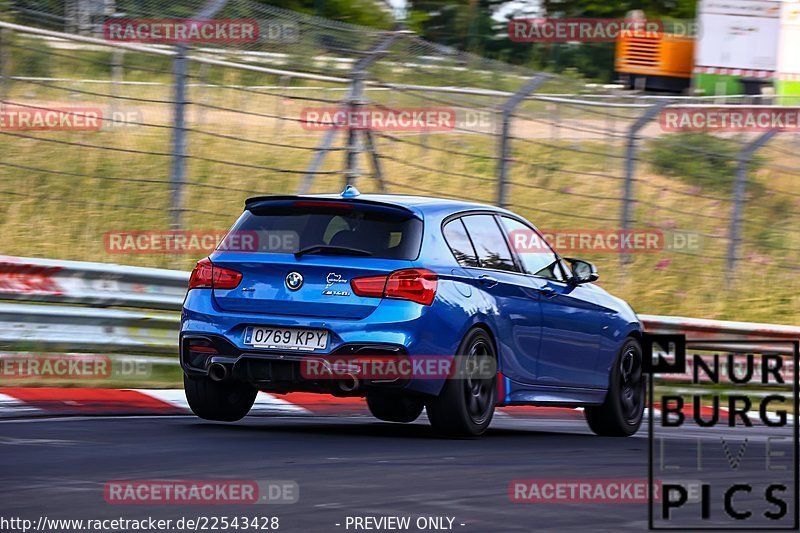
[{"x1": 180, "y1": 290, "x2": 463, "y2": 395}]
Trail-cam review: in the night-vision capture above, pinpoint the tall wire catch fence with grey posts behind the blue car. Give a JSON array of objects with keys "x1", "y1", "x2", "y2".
[{"x1": 0, "y1": 0, "x2": 800, "y2": 322}]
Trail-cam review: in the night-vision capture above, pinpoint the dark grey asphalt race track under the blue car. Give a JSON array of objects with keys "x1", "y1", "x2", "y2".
[{"x1": 0, "y1": 416, "x2": 792, "y2": 532}]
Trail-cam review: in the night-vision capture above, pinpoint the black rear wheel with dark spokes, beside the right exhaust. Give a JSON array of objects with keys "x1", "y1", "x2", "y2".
[{"x1": 426, "y1": 328, "x2": 497, "y2": 437}]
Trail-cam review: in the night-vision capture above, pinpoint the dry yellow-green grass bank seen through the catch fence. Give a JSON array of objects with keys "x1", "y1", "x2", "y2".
[{"x1": 0, "y1": 47, "x2": 800, "y2": 324}]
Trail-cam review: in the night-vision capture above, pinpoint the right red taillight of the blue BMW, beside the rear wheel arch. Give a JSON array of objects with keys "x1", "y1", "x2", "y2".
[{"x1": 350, "y1": 268, "x2": 437, "y2": 305}]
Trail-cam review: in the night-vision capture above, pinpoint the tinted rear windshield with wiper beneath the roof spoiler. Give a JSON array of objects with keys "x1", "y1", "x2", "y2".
[{"x1": 217, "y1": 206, "x2": 422, "y2": 260}]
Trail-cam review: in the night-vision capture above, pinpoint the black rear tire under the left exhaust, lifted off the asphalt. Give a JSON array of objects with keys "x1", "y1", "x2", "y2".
[{"x1": 183, "y1": 374, "x2": 258, "y2": 422}]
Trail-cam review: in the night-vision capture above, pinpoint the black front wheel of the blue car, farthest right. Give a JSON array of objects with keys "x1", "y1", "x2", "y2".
[{"x1": 583, "y1": 338, "x2": 645, "y2": 437}]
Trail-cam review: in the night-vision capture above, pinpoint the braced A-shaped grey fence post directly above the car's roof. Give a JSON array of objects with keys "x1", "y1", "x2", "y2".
[{"x1": 298, "y1": 30, "x2": 412, "y2": 194}]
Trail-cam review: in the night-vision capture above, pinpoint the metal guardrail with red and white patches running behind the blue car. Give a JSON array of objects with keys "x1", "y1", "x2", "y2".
[{"x1": 0, "y1": 256, "x2": 800, "y2": 355}]
